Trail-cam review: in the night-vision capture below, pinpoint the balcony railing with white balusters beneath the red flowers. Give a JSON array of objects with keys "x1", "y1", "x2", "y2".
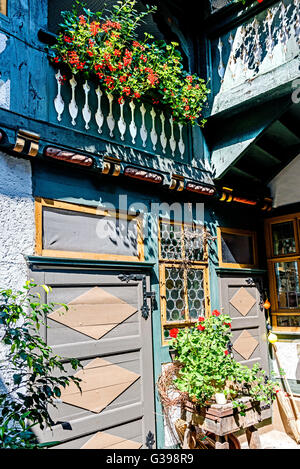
[{"x1": 52, "y1": 70, "x2": 190, "y2": 163}]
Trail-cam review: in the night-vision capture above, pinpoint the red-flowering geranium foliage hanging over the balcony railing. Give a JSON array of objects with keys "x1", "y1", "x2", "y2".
[{"x1": 51, "y1": 0, "x2": 209, "y2": 125}]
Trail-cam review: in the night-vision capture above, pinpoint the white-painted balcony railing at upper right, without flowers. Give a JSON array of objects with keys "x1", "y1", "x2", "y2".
[{"x1": 211, "y1": 0, "x2": 300, "y2": 109}]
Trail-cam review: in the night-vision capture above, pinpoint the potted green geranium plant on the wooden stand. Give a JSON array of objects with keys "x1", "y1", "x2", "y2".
[{"x1": 171, "y1": 310, "x2": 275, "y2": 414}]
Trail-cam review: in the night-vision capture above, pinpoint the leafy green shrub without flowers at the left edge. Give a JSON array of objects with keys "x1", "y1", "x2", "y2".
[{"x1": 0, "y1": 281, "x2": 80, "y2": 449}]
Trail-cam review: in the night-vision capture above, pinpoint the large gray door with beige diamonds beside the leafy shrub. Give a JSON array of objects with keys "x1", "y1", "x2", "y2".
[{"x1": 33, "y1": 269, "x2": 155, "y2": 449}]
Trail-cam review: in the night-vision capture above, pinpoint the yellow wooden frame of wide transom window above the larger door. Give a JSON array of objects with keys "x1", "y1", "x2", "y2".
[{"x1": 35, "y1": 197, "x2": 145, "y2": 262}]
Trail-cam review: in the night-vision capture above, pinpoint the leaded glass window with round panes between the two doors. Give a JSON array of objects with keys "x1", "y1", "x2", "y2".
[{"x1": 159, "y1": 221, "x2": 208, "y2": 344}]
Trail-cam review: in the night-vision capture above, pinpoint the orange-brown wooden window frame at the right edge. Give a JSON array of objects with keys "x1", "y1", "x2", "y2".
[{"x1": 265, "y1": 212, "x2": 300, "y2": 332}]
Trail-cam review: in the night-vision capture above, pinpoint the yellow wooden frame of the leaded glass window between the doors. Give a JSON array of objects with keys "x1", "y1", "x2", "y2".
[{"x1": 158, "y1": 217, "x2": 210, "y2": 346}]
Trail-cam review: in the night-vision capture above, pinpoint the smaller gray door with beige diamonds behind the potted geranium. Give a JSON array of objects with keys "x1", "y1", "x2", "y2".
[{"x1": 220, "y1": 271, "x2": 269, "y2": 373}]
